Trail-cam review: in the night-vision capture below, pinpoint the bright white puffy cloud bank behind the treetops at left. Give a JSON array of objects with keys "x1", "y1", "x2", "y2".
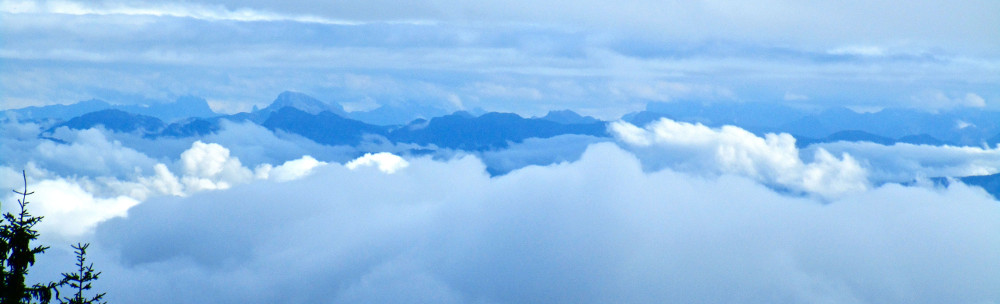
[{"x1": 0, "y1": 134, "x2": 342, "y2": 240}]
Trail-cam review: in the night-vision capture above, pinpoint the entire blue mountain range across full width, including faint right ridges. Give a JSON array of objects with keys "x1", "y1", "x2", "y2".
[{"x1": 11, "y1": 92, "x2": 1000, "y2": 196}]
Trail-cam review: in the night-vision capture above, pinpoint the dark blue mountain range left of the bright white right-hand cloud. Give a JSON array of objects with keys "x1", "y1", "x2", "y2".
[{"x1": 27, "y1": 92, "x2": 608, "y2": 151}]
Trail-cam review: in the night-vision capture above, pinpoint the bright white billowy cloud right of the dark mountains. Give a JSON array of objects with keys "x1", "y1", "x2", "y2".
[{"x1": 609, "y1": 118, "x2": 869, "y2": 197}]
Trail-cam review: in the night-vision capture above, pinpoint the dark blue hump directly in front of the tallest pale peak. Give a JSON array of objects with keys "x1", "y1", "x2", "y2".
[{"x1": 261, "y1": 107, "x2": 386, "y2": 145}]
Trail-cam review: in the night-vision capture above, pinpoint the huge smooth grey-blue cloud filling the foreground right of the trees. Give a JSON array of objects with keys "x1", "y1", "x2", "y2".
[{"x1": 76, "y1": 143, "x2": 1000, "y2": 303}]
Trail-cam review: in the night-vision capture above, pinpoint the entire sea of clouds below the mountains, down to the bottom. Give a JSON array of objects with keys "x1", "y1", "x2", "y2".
[{"x1": 0, "y1": 119, "x2": 1000, "y2": 303}]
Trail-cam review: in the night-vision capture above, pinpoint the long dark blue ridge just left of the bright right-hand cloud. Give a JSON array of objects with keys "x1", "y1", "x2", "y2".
[{"x1": 389, "y1": 112, "x2": 608, "y2": 151}]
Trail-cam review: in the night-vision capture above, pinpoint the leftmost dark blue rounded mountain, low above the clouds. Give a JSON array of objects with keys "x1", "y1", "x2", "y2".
[{"x1": 46, "y1": 109, "x2": 164, "y2": 134}]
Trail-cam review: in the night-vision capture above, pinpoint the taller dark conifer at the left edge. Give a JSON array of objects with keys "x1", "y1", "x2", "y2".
[{"x1": 0, "y1": 171, "x2": 58, "y2": 304}]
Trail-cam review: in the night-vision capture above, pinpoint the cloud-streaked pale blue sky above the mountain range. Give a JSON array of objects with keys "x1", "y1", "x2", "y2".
[{"x1": 0, "y1": 0, "x2": 1000, "y2": 119}]
